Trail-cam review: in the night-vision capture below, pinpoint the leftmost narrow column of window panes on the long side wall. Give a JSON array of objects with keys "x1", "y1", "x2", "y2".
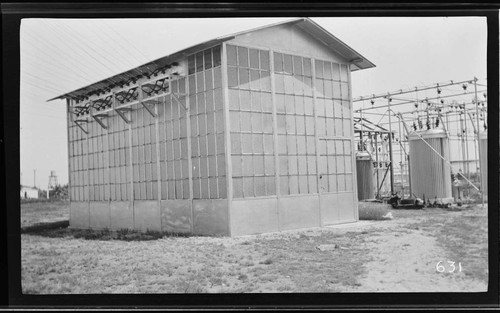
[{"x1": 69, "y1": 120, "x2": 88, "y2": 201}]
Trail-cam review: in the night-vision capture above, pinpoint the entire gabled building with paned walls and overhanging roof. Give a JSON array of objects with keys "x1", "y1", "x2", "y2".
[{"x1": 54, "y1": 18, "x2": 374, "y2": 236}]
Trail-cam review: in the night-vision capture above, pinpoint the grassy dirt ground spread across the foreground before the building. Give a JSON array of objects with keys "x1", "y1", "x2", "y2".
[{"x1": 21, "y1": 201, "x2": 488, "y2": 294}]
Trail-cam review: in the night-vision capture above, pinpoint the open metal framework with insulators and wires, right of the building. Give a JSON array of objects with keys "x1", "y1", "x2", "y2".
[{"x1": 353, "y1": 77, "x2": 487, "y2": 201}]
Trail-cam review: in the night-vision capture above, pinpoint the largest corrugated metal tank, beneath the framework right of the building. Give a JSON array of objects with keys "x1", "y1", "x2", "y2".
[{"x1": 408, "y1": 128, "x2": 453, "y2": 203}]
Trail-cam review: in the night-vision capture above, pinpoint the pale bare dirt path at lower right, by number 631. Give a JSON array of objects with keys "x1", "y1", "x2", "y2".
[{"x1": 342, "y1": 207, "x2": 487, "y2": 292}]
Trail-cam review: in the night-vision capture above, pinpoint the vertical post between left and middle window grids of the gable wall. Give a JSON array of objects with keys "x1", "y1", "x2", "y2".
[{"x1": 269, "y1": 50, "x2": 282, "y2": 231}]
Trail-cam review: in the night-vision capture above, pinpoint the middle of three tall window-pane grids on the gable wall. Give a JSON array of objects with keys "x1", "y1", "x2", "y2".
[{"x1": 274, "y1": 52, "x2": 318, "y2": 195}]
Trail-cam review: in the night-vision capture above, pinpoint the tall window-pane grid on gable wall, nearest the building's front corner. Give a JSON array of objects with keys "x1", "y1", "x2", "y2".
[{"x1": 227, "y1": 45, "x2": 276, "y2": 198}]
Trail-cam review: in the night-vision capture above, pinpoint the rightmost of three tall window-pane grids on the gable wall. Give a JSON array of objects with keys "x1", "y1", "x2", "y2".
[{"x1": 314, "y1": 60, "x2": 353, "y2": 192}]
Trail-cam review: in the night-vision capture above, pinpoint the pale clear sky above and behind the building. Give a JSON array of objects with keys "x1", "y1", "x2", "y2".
[{"x1": 20, "y1": 17, "x2": 487, "y2": 188}]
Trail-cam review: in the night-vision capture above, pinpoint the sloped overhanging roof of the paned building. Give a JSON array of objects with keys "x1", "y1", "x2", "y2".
[{"x1": 47, "y1": 18, "x2": 375, "y2": 101}]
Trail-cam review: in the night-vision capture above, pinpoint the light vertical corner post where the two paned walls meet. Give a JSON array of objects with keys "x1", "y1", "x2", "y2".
[{"x1": 221, "y1": 42, "x2": 233, "y2": 236}]
